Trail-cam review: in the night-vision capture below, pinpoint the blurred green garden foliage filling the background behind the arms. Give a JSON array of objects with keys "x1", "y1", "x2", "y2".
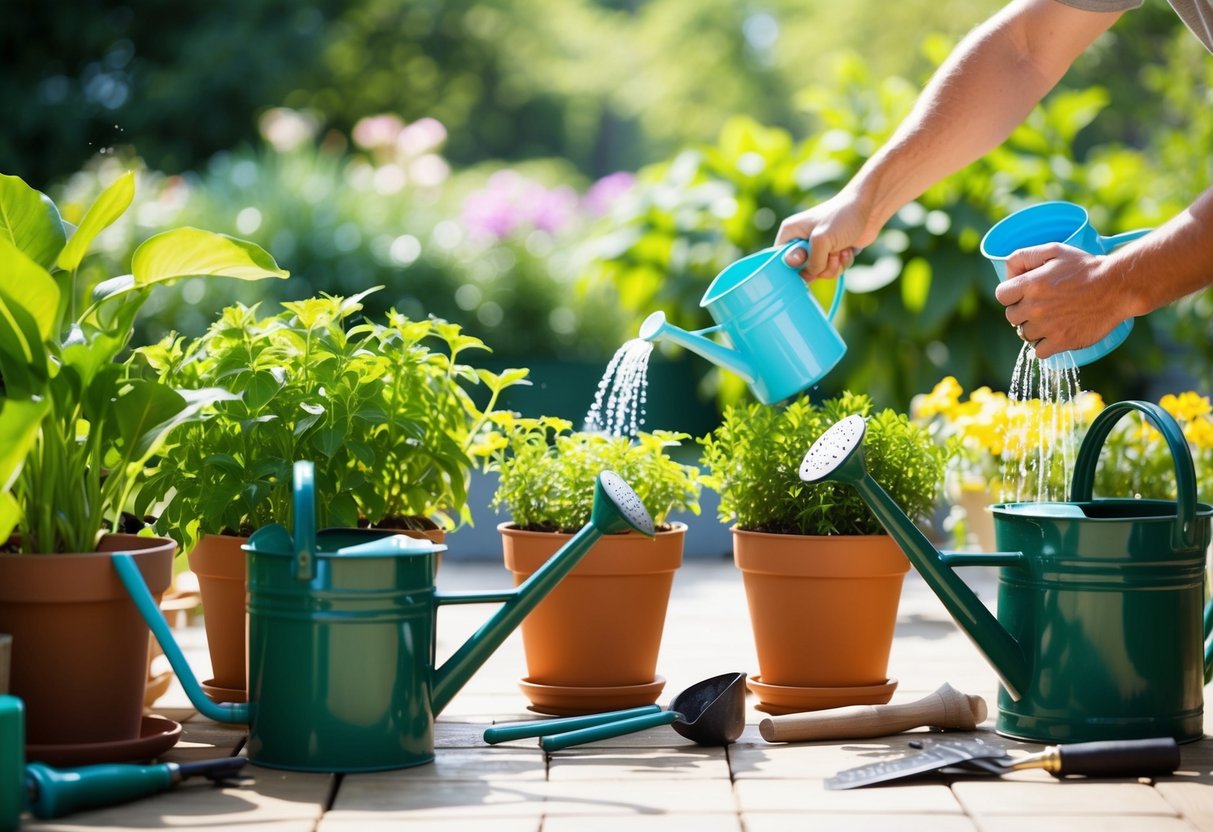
[{"x1": 11, "y1": 0, "x2": 1213, "y2": 408}]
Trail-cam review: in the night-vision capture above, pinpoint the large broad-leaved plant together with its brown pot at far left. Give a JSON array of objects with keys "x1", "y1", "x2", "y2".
[{"x1": 0, "y1": 173, "x2": 287, "y2": 763}]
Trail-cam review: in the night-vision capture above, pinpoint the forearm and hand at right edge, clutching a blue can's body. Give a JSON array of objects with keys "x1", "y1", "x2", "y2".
[{"x1": 995, "y1": 188, "x2": 1213, "y2": 359}]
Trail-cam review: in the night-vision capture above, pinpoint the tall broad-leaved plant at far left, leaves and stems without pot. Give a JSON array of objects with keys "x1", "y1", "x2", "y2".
[{"x1": 0, "y1": 173, "x2": 287, "y2": 553}]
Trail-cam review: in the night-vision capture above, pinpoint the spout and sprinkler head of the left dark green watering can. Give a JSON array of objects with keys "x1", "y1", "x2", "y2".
[{"x1": 432, "y1": 471, "x2": 656, "y2": 714}]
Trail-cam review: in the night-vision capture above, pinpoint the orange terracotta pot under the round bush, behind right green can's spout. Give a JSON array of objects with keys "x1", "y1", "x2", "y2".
[{"x1": 733, "y1": 529, "x2": 910, "y2": 703}]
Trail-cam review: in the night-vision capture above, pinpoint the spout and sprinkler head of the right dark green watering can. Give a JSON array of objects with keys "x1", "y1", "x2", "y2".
[{"x1": 799, "y1": 415, "x2": 1031, "y2": 700}]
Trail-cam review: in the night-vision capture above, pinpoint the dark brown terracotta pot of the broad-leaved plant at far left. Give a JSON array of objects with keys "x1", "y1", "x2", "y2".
[{"x1": 0, "y1": 535, "x2": 177, "y2": 762}]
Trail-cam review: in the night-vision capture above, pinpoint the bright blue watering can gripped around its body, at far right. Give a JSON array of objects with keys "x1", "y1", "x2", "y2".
[{"x1": 981, "y1": 201, "x2": 1151, "y2": 370}]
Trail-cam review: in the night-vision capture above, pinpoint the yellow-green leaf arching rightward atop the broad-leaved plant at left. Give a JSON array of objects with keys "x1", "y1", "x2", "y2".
[{"x1": 131, "y1": 228, "x2": 290, "y2": 286}]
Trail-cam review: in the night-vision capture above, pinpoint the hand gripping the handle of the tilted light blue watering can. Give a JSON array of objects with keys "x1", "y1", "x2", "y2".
[{"x1": 775, "y1": 193, "x2": 876, "y2": 280}]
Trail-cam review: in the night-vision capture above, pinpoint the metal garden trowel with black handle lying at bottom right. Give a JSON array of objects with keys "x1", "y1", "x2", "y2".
[{"x1": 825, "y1": 736, "x2": 1179, "y2": 790}]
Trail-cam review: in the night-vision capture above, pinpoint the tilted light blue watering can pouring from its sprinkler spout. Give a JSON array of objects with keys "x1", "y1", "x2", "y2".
[{"x1": 639, "y1": 240, "x2": 847, "y2": 404}]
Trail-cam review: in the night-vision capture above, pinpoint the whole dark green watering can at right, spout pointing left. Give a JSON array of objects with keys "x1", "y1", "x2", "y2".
[{"x1": 801, "y1": 401, "x2": 1213, "y2": 742}]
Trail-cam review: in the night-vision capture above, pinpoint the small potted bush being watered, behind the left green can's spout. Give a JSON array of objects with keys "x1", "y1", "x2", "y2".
[{"x1": 490, "y1": 416, "x2": 700, "y2": 713}]
